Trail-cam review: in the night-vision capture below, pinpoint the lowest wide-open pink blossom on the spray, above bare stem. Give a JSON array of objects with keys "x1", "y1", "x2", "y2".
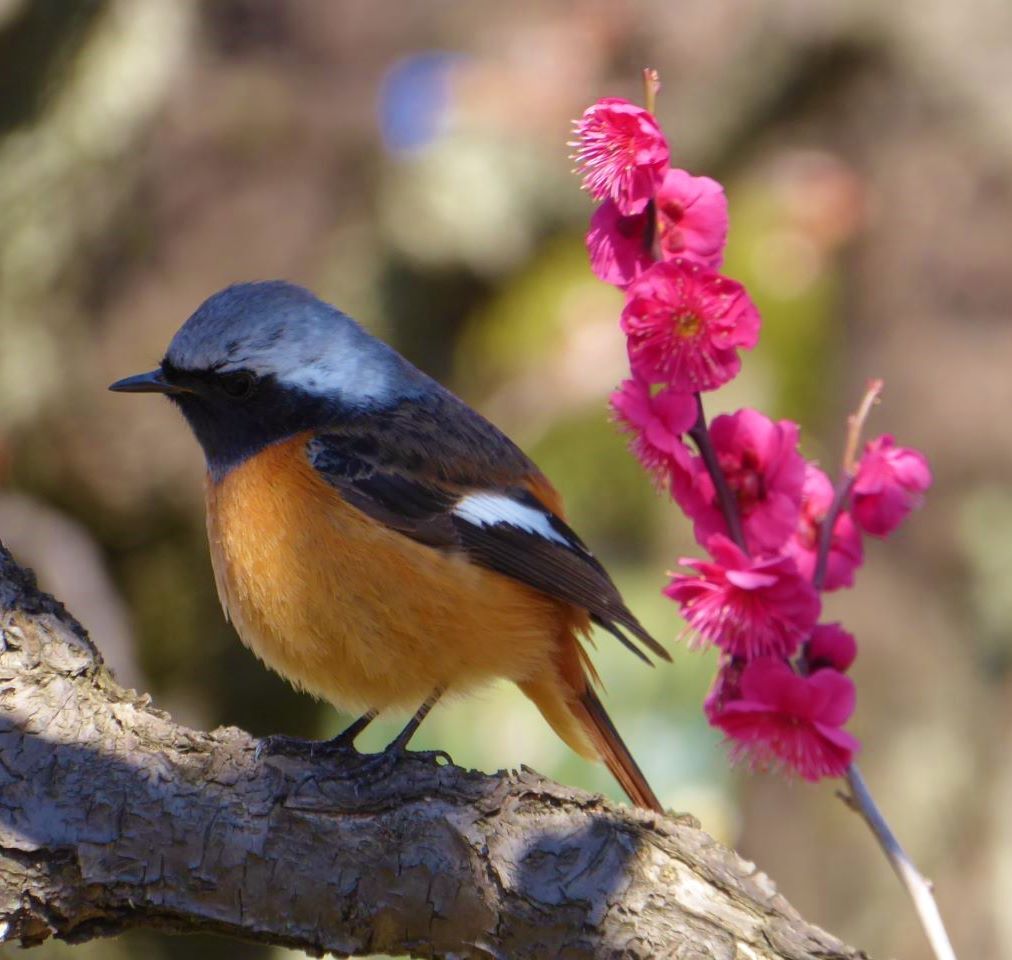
[{"x1": 711, "y1": 658, "x2": 860, "y2": 781}]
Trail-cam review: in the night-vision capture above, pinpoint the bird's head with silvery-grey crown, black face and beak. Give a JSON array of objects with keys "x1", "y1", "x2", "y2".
[{"x1": 109, "y1": 280, "x2": 423, "y2": 479}]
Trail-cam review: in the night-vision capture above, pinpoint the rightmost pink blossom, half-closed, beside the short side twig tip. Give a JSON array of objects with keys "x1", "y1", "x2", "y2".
[{"x1": 853, "y1": 434, "x2": 931, "y2": 537}]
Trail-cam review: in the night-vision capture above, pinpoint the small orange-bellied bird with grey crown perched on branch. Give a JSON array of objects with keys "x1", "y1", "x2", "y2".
[{"x1": 109, "y1": 280, "x2": 670, "y2": 812}]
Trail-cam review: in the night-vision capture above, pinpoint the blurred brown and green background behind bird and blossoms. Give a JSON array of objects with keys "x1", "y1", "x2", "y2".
[{"x1": 0, "y1": 0, "x2": 1012, "y2": 960}]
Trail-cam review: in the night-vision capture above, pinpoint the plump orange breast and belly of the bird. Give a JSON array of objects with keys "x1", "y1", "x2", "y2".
[{"x1": 207, "y1": 436, "x2": 586, "y2": 716}]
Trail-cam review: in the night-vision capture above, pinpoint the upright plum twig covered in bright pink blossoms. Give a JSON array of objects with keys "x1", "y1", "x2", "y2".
[{"x1": 571, "y1": 71, "x2": 954, "y2": 960}]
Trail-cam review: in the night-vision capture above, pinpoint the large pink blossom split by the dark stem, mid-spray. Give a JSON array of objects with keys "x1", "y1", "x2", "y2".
[{"x1": 672, "y1": 410, "x2": 805, "y2": 553}]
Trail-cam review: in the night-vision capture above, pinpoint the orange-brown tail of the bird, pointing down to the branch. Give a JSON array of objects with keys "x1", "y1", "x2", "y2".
[{"x1": 519, "y1": 639, "x2": 664, "y2": 813}]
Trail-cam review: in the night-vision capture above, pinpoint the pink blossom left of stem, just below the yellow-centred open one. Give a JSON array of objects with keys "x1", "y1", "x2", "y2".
[{"x1": 609, "y1": 379, "x2": 697, "y2": 481}]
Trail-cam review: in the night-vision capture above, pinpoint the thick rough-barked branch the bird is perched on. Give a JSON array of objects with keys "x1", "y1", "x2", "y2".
[{"x1": 0, "y1": 547, "x2": 864, "y2": 960}]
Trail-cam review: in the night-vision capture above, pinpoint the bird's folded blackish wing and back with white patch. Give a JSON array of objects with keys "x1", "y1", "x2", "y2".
[{"x1": 307, "y1": 394, "x2": 670, "y2": 663}]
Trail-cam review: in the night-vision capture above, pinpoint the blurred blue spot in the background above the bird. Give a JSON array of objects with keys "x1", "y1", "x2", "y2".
[{"x1": 380, "y1": 51, "x2": 463, "y2": 151}]
